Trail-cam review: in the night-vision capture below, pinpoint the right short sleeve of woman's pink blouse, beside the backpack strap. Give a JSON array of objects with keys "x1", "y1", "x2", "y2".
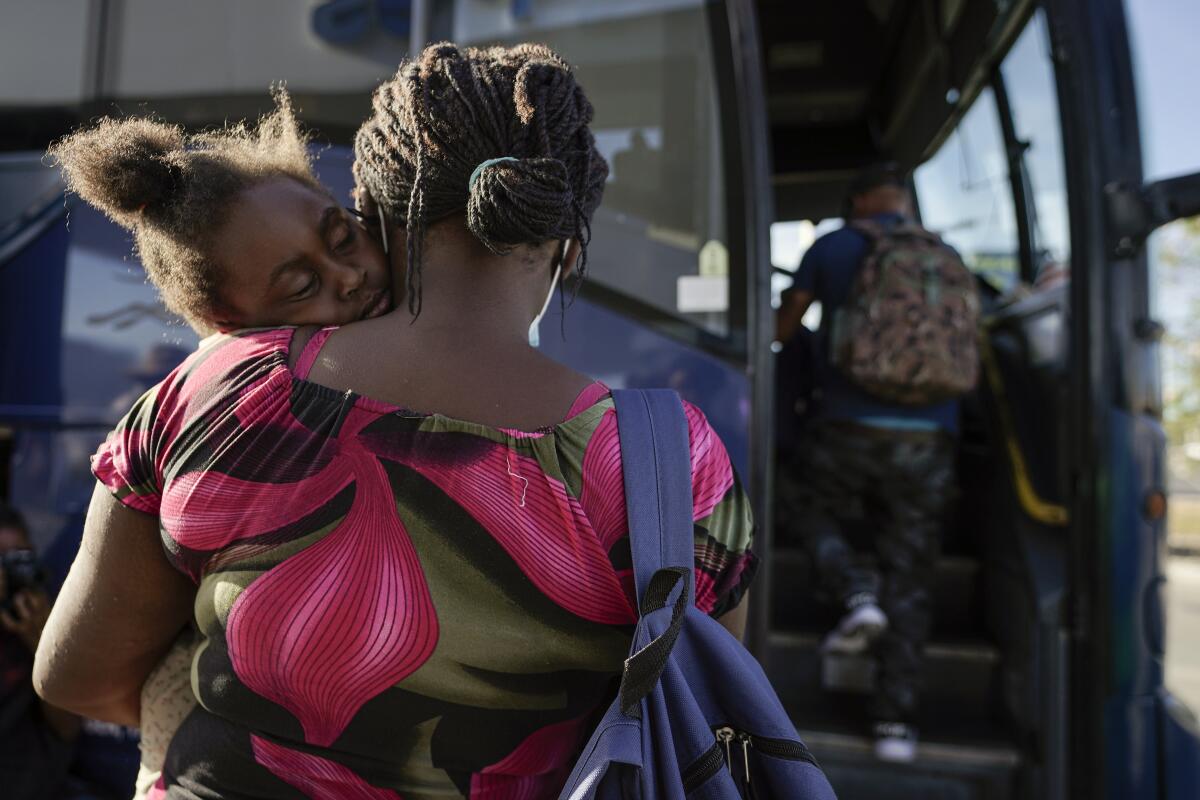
[{"x1": 684, "y1": 403, "x2": 758, "y2": 616}]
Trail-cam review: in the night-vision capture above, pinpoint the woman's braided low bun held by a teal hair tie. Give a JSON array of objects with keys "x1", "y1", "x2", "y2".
[{"x1": 467, "y1": 158, "x2": 575, "y2": 255}]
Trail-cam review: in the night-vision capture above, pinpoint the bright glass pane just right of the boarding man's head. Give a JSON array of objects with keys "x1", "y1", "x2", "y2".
[{"x1": 913, "y1": 88, "x2": 1019, "y2": 290}]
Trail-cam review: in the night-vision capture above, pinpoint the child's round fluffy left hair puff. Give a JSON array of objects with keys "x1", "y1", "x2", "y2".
[{"x1": 49, "y1": 118, "x2": 187, "y2": 228}]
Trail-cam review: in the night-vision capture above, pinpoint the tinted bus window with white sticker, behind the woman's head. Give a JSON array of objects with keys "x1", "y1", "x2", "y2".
[{"x1": 454, "y1": 0, "x2": 724, "y2": 335}]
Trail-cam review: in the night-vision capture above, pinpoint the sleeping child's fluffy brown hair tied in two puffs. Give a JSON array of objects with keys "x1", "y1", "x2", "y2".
[{"x1": 48, "y1": 89, "x2": 325, "y2": 329}]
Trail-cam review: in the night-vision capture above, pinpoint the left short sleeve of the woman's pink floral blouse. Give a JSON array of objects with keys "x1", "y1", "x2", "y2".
[{"x1": 91, "y1": 384, "x2": 166, "y2": 515}]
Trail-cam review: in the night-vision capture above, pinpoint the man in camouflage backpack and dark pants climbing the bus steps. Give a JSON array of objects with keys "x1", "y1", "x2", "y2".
[{"x1": 778, "y1": 163, "x2": 979, "y2": 762}]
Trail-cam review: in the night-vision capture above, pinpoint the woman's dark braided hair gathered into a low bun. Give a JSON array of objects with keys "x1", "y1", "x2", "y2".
[{"x1": 354, "y1": 42, "x2": 608, "y2": 314}]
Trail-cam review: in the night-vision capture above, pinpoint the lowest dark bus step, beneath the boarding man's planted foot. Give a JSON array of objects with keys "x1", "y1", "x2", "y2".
[{"x1": 797, "y1": 723, "x2": 1021, "y2": 800}]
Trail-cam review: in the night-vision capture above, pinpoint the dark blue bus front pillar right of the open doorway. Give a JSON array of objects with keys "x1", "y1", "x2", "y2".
[{"x1": 1046, "y1": 0, "x2": 1200, "y2": 798}]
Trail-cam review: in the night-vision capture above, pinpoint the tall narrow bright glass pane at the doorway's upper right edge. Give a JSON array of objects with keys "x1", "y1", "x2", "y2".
[{"x1": 1000, "y1": 11, "x2": 1070, "y2": 272}]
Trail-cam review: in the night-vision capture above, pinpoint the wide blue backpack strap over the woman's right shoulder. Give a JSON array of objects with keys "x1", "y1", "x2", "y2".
[{"x1": 612, "y1": 389, "x2": 696, "y2": 606}]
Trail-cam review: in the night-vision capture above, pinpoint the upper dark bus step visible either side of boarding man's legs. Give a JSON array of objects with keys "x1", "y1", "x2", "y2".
[{"x1": 770, "y1": 548, "x2": 985, "y2": 639}]
